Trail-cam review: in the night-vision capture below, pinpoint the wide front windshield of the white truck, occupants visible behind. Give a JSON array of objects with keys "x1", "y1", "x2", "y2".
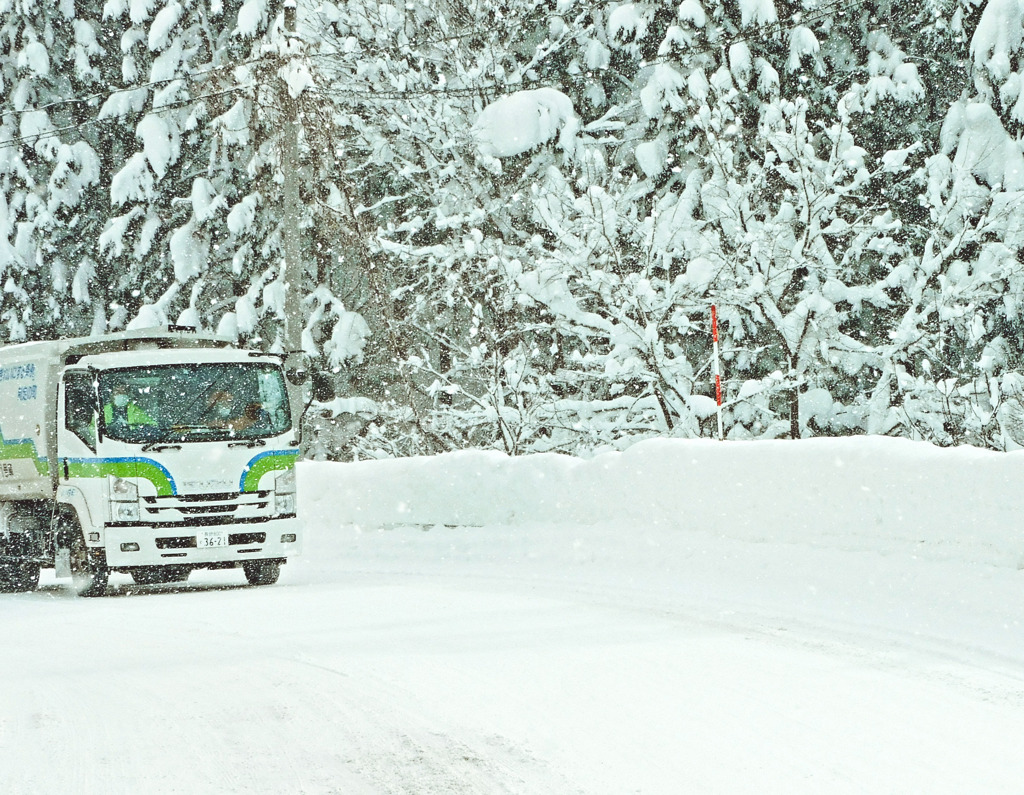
[{"x1": 99, "y1": 362, "x2": 291, "y2": 443}]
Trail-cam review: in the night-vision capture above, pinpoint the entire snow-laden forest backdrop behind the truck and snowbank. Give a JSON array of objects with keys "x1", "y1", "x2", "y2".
[{"x1": 0, "y1": 0, "x2": 1024, "y2": 457}]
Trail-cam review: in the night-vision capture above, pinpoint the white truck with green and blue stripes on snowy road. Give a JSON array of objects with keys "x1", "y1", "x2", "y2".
[{"x1": 0, "y1": 327, "x2": 301, "y2": 596}]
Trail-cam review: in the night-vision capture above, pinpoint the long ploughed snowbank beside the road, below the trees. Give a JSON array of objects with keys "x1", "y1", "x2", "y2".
[{"x1": 300, "y1": 436, "x2": 1024, "y2": 567}]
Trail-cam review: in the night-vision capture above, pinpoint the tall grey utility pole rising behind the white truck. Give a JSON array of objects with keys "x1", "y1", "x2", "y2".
[{"x1": 281, "y1": 0, "x2": 306, "y2": 383}]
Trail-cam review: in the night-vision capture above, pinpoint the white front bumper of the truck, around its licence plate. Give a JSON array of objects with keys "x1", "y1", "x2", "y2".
[{"x1": 101, "y1": 517, "x2": 302, "y2": 569}]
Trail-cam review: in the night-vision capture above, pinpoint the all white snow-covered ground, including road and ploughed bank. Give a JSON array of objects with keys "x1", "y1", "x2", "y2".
[{"x1": 0, "y1": 438, "x2": 1024, "y2": 793}]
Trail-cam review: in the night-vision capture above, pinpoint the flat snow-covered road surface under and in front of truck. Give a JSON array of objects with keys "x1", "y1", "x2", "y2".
[{"x1": 0, "y1": 518, "x2": 1024, "y2": 793}]
